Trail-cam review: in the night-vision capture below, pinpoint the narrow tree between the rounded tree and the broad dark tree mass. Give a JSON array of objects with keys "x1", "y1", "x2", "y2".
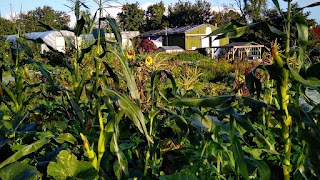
[{"x1": 145, "y1": 1, "x2": 169, "y2": 31}]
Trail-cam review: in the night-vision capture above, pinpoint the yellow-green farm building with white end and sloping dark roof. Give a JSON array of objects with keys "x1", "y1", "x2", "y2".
[{"x1": 141, "y1": 24, "x2": 229, "y2": 50}]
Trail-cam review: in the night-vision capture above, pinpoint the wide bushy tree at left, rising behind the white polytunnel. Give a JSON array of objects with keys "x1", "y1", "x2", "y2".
[{"x1": 17, "y1": 6, "x2": 70, "y2": 32}]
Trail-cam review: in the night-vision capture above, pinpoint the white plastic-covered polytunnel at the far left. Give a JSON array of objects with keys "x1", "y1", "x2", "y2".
[{"x1": 6, "y1": 30, "x2": 76, "y2": 53}]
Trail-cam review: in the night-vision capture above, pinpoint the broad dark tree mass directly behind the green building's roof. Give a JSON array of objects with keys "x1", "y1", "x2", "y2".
[{"x1": 168, "y1": 0, "x2": 212, "y2": 27}]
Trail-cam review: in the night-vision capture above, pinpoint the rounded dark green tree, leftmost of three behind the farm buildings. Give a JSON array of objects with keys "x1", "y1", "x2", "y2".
[{"x1": 118, "y1": 2, "x2": 144, "y2": 31}]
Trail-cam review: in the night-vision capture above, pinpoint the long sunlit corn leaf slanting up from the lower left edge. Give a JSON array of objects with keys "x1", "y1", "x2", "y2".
[{"x1": 0, "y1": 139, "x2": 48, "y2": 169}]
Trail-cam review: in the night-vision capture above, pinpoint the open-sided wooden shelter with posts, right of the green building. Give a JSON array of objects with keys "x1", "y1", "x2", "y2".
[{"x1": 211, "y1": 42, "x2": 264, "y2": 60}]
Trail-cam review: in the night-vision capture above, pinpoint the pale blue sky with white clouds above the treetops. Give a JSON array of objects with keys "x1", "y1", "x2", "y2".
[{"x1": 0, "y1": 0, "x2": 320, "y2": 24}]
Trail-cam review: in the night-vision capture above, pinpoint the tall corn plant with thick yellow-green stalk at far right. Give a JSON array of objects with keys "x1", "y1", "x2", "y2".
[{"x1": 199, "y1": 0, "x2": 320, "y2": 179}]
